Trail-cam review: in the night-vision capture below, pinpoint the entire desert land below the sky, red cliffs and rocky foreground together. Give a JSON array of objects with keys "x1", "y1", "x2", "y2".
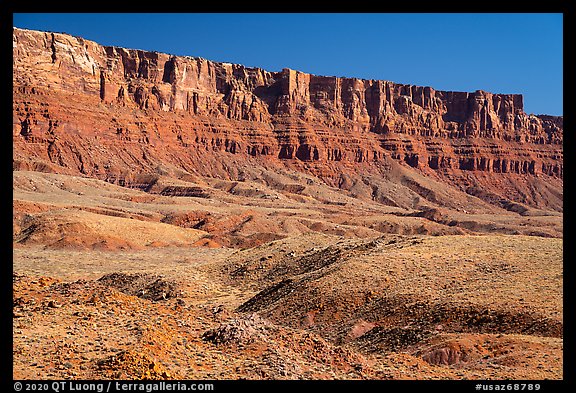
[{"x1": 13, "y1": 28, "x2": 563, "y2": 379}]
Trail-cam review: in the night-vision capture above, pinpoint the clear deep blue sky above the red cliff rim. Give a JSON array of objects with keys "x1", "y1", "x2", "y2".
[{"x1": 13, "y1": 13, "x2": 563, "y2": 115}]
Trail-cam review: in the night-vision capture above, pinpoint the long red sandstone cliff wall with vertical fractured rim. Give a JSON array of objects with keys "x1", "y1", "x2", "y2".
[{"x1": 13, "y1": 28, "x2": 563, "y2": 211}]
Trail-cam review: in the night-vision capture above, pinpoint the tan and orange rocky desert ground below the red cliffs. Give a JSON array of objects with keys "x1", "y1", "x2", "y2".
[{"x1": 13, "y1": 171, "x2": 563, "y2": 379}]
